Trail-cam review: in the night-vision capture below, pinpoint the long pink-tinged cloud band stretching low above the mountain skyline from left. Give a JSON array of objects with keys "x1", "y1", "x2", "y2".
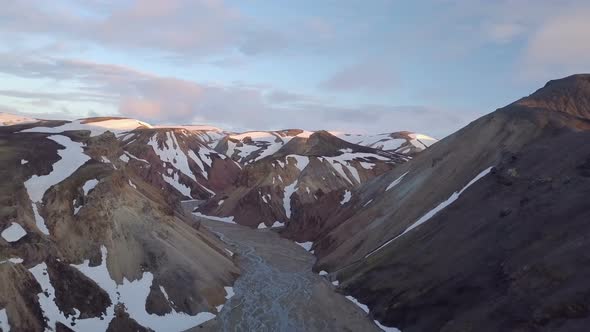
[{"x1": 0, "y1": 54, "x2": 462, "y2": 137}]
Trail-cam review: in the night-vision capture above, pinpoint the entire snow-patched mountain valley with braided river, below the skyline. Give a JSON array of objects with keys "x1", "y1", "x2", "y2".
[{"x1": 0, "y1": 74, "x2": 590, "y2": 332}]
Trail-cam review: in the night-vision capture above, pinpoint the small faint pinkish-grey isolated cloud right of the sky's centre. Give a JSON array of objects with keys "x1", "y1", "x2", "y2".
[{"x1": 319, "y1": 59, "x2": 398, "y2": 93}]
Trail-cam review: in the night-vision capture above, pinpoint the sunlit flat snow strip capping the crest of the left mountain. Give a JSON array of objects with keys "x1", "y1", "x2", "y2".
[{"x1": 21, "y1": 119, "x2": 151, "y2": 136}]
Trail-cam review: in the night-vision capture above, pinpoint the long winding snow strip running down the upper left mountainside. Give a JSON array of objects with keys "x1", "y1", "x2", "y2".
[{"x1": 25, "y1": 135, "x2": 90, "y2": 235}]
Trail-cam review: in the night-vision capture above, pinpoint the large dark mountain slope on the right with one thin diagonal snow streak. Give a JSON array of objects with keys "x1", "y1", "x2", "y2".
[{"x1": 309, "y1": 75, "x2": 590, "y2": 332}]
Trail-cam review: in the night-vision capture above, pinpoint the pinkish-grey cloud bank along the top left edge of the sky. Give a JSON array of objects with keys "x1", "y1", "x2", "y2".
[{"x1": 0, "y1": 0, "x2": 286, "y2": 58}]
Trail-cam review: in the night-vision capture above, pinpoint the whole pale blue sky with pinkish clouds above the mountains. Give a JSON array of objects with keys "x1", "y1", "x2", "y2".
[{"x1": 0, "y1": 0, "x2": 590, "y2": 138}]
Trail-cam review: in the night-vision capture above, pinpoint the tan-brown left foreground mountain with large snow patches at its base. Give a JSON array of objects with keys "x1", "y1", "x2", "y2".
[{"x1": 0, "y1": 119, "x2": 239, "y2": 331}]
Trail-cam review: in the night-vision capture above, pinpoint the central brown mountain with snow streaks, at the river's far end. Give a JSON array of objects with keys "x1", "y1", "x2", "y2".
[{"x1": 197, "y1": 131, "x2": 409, "y2": 233}]
